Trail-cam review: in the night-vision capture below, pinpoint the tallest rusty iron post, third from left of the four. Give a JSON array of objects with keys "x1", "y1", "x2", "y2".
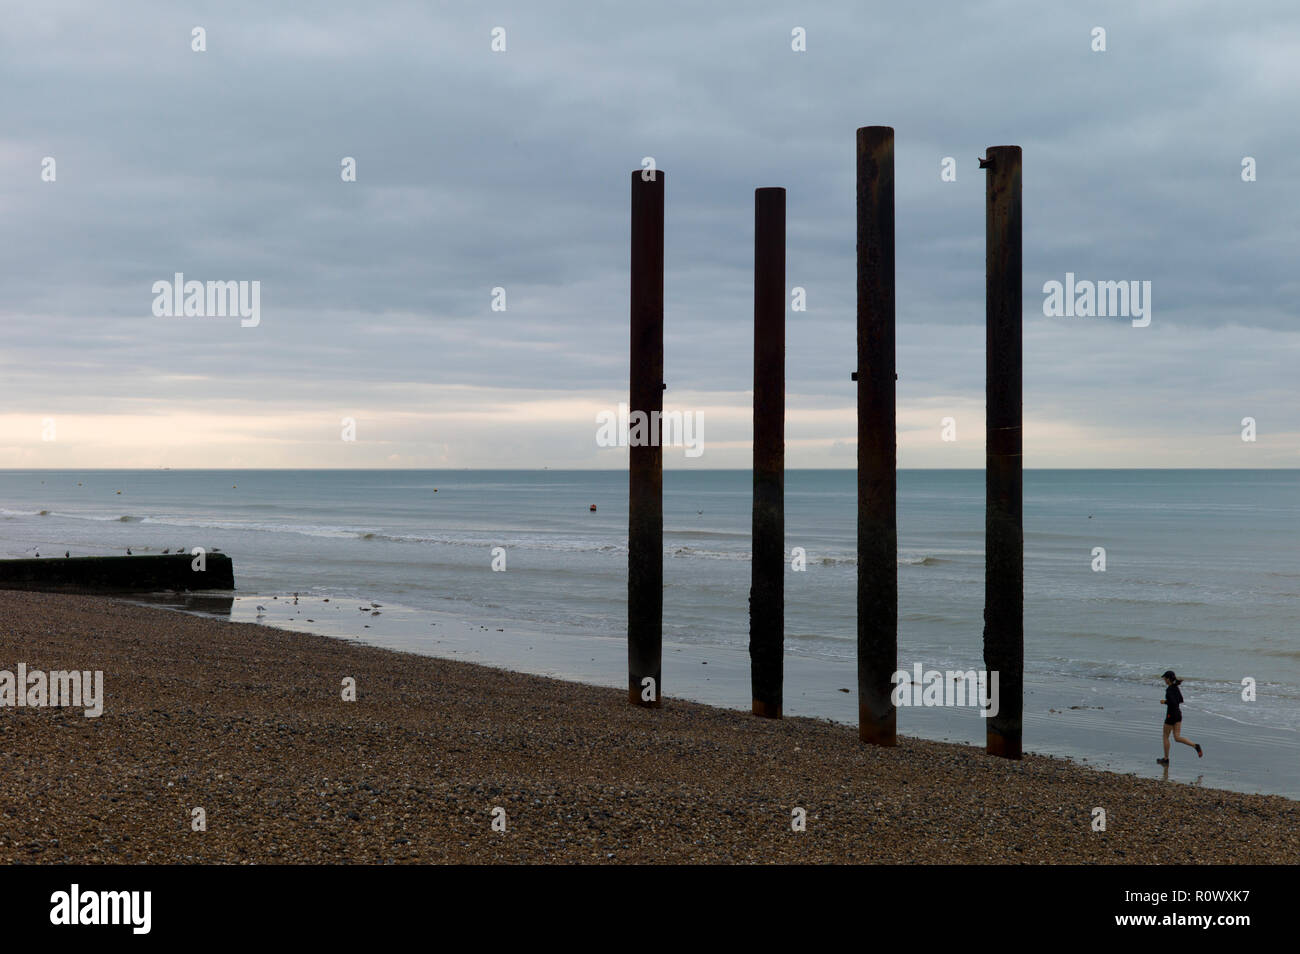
[{"x1": 855, "y1": 126, "x2": 898, "y2": 745}]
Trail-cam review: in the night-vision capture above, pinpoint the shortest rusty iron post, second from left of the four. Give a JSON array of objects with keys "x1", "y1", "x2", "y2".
[{"x1": 749, "y1": 188, "x2": 785, "y2": 719}]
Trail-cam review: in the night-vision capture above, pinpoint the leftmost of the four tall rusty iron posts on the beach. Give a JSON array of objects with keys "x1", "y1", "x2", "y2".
[{"x1": 628, "y1": 169, "x2": 664, "y2": 707}]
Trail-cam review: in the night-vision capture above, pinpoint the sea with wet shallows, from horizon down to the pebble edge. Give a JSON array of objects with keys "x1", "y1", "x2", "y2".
[{"x1": 0, "y1": 469, "x2": 1300, "y2": 798}]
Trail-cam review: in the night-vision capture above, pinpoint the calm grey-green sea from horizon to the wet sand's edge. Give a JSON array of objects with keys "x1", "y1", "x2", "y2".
[{"x1": 0, "y1": 471, "x2": 1300, "y2": 790}]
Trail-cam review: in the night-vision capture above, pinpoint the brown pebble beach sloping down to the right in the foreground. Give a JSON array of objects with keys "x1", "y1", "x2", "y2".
[{"x1": 0, "y1": 591, "x2": 1300, "y2": 864}]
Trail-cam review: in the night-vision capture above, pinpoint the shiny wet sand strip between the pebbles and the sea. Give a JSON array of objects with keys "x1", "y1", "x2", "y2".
[{"x1": 139, "y1": 594, "x2": 1300, "y2": 801}]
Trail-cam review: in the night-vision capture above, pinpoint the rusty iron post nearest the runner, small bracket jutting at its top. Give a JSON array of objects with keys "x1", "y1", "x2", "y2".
[{"x1": 980, "y1": 146, "x2": 1024, "y2": 759}]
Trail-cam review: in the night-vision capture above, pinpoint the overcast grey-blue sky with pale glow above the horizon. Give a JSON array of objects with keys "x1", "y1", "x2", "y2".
[{"x1": 0, "y1": 0, "x2": 1300, "y2": 468}]
